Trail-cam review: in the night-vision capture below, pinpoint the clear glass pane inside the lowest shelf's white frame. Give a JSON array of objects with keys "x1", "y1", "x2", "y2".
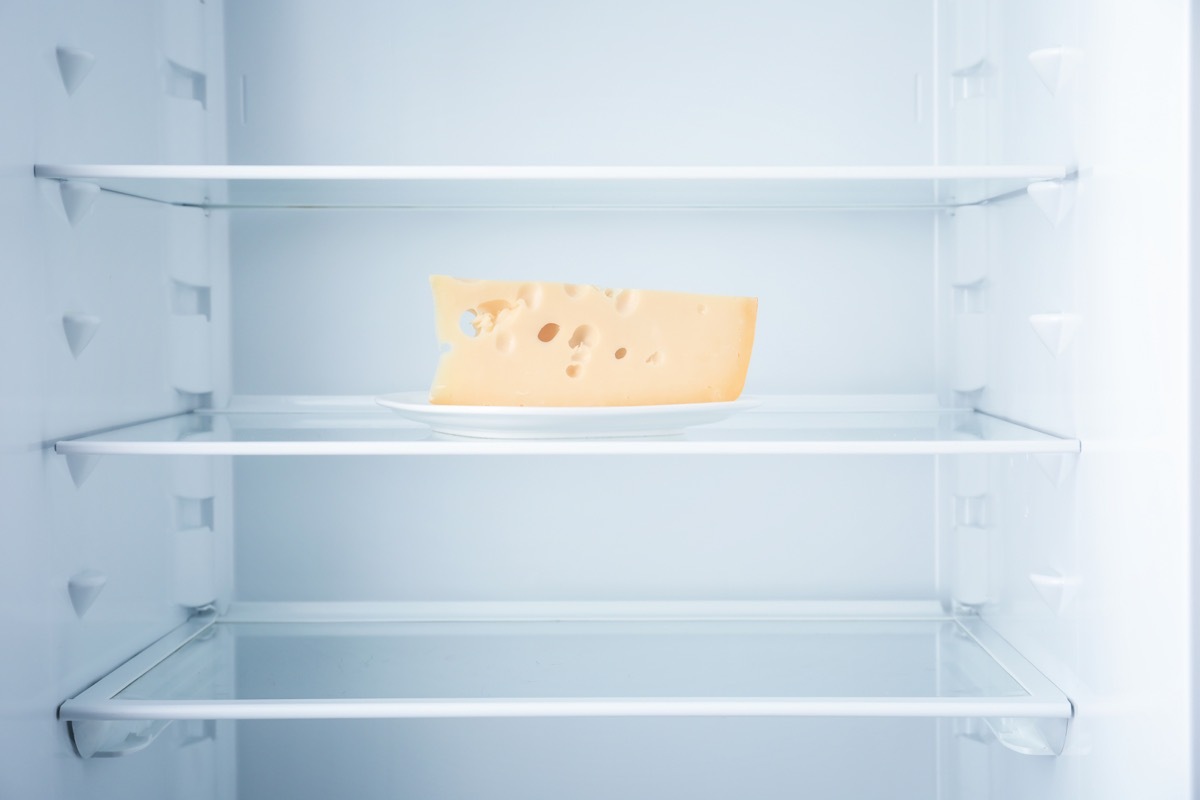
[{"x1": 118, "y1": 620, "x2": 1027, "y2": 700}]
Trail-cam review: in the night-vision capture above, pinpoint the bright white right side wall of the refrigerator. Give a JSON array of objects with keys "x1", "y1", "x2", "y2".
[{"x1": 979, "y1": 0, "x2": 1194, "y2": 800}]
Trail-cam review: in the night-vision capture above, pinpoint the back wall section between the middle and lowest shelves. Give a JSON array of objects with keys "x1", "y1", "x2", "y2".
[{"x1": 235, "y1": 456, "x2": 935, "y2": 601}]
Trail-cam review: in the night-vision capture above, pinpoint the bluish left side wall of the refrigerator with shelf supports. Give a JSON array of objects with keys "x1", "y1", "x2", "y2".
[{"x1": 0, "y1": 0, "x2": 232, "y2": 800}]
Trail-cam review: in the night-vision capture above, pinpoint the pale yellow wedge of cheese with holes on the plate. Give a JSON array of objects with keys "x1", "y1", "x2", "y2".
[{"x1": 430, "y1": 275, "x2": 758, "y2": 405}]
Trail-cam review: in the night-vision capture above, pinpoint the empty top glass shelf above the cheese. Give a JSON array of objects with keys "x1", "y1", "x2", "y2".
[{"x1": 34, "y1": 164, "x2": 1069, "y2": 209}]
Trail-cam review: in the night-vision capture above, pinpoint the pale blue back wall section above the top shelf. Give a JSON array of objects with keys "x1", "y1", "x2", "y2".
[{"x1": 227, "y1": 0, "x2": 934, "y2": 164}]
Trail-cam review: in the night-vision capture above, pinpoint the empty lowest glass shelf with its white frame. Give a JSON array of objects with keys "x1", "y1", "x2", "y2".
[{"x1": 59, "y1": 603, "x2": 1072, "y2": 722}]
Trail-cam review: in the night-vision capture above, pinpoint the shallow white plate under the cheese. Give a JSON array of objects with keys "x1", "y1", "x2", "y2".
[{"x1": 376, "y1": 392, "x2": 758, "y2": 439}]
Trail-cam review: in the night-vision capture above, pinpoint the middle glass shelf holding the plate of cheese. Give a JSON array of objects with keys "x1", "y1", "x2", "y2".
[{"x1": 55, "y1": 403, "x2": 1080, "y2": 457}]
